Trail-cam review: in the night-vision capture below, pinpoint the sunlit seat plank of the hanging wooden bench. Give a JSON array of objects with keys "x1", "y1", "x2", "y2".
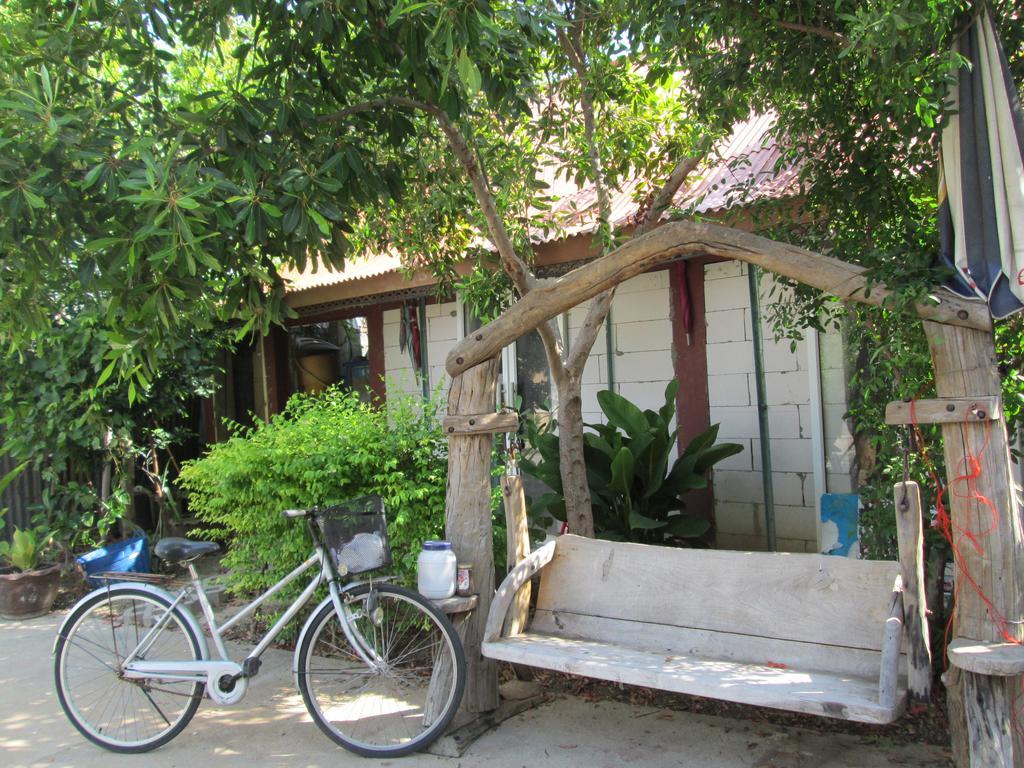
[{"x1": 483, "y1": 633, "x2": 904, "y2": 723}]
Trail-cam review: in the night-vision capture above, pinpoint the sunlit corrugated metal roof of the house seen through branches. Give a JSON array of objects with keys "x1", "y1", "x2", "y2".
[{"x1": 284, "y1": 115, "x2": 799, "y2": 294}]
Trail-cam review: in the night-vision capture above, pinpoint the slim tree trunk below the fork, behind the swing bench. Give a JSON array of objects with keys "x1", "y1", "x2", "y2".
[{"x1": 555, "y1": 373, "x2": 594, "y2": 539}]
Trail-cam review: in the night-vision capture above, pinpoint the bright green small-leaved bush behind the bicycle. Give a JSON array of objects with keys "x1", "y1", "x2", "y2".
[{"x1": 179, "y1": 389, "x2": 447, "y2": 592}]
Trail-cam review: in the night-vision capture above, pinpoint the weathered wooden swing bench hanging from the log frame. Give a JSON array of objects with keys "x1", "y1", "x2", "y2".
[{"x1": 482, "y1": 535, "x2": 906, "y2": 723}]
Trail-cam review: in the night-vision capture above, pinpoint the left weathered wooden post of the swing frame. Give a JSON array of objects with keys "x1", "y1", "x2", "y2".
[{"x1": 444, "y1": 359, "x2": 498, "y2": 714}]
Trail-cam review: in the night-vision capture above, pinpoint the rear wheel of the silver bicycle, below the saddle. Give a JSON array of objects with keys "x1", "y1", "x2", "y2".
[{"x1": 53, "y1": 588, "x2": 205, "y2": 754}]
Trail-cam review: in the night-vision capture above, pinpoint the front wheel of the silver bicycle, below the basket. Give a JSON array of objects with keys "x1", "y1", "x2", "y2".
[{"x1": 297, "y1": 584, "x2": 466, "y2": 758}]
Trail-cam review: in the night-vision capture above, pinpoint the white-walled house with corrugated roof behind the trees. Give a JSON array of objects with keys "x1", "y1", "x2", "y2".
[{"x1": 241, "y1": 117, "x2": 854, "y2": 552}]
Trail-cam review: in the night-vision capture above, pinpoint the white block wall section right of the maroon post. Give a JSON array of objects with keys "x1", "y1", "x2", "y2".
[{"x1": 705, "y1": 262, "x2": 853, "y2": 552}]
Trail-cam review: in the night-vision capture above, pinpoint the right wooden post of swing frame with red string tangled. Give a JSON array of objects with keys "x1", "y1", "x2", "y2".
[{"x1": 924, "y1": 321, "x2": 1024, "y2": 768}]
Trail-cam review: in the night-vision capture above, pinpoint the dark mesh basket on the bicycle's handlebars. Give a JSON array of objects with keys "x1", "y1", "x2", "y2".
[{"x1": 316, "y1": 496, "x2": 391, "y2": 575}]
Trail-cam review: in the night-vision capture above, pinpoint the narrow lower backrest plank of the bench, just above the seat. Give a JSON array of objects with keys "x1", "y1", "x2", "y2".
[{"x1": 529, "y1": 610, "x2": 906, "y2": 680}]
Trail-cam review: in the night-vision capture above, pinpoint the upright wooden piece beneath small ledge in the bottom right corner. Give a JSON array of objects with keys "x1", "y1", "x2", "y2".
[{"x1": 964, "y1": 672, "x2": 1017, "y2": 768}]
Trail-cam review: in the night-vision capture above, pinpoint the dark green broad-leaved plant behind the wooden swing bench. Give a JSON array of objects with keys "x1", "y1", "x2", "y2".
[{"x1": 522, "y1": 380, "x2": 743, "y2": 544}]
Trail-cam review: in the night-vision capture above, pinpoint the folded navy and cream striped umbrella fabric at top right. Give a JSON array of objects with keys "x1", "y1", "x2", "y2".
[{"x1": 939, "y1": 4, "x2": 1024, "y2": 318}]
